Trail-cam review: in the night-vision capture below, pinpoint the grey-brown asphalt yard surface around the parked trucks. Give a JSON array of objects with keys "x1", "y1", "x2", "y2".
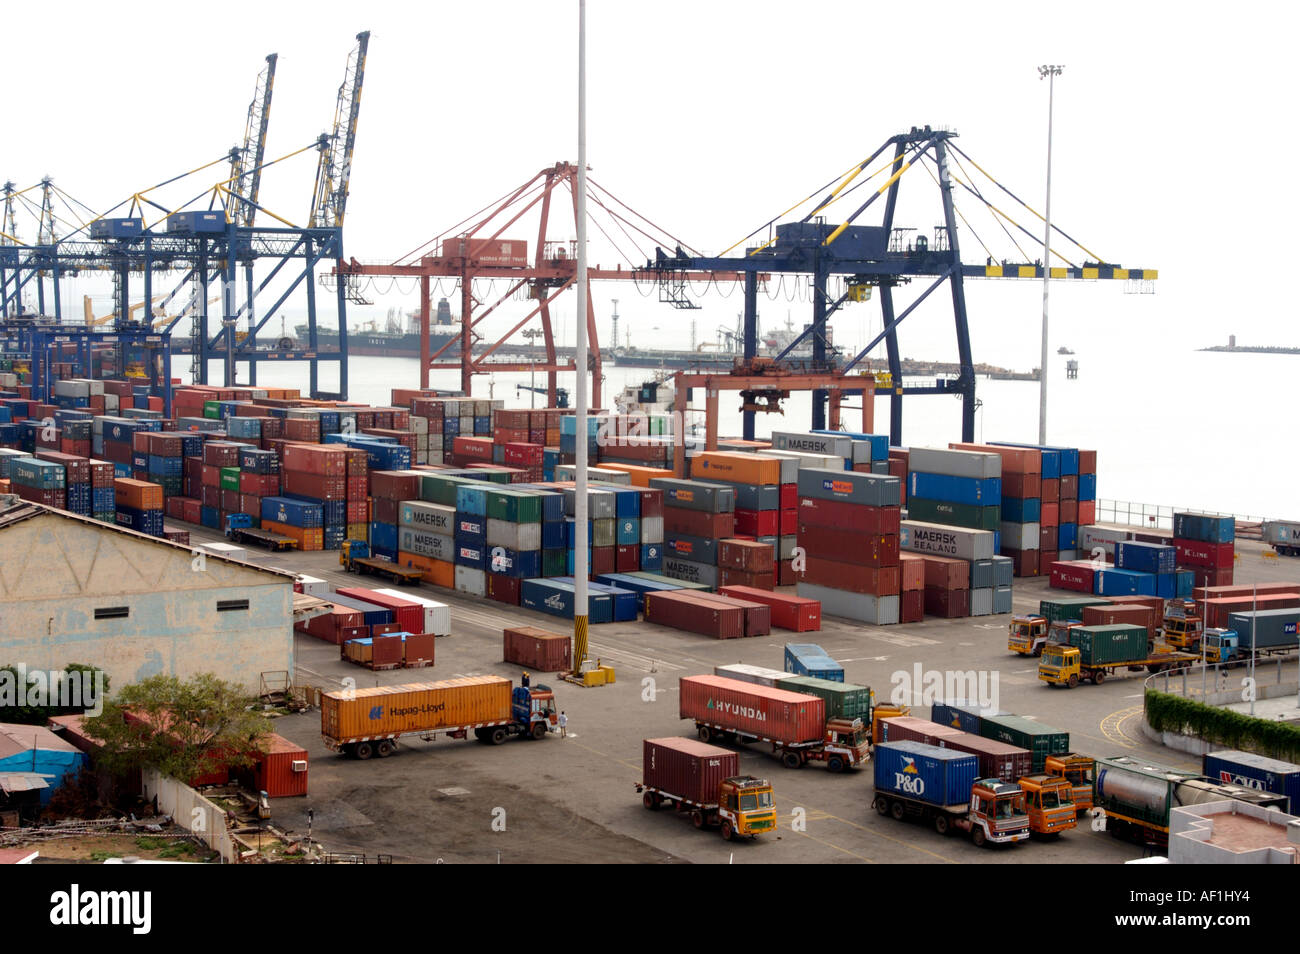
[{"x1": 192, "y1": 530, "x2": 1300, "y2": 864}]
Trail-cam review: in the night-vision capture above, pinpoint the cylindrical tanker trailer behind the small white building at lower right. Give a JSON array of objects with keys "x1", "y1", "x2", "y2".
[{"x1": 1092, "y1": 755, "x2": 1287, "y2": 847}]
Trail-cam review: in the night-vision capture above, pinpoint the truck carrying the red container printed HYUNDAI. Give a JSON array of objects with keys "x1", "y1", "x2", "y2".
[{"x1": 679, "y1": 676, "x2": 871, "y2": 772}]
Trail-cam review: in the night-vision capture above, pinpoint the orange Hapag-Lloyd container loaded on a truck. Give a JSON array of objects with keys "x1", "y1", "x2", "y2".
[{"x1": 321, "y1": 676, "x2": 511, "y2": 746}]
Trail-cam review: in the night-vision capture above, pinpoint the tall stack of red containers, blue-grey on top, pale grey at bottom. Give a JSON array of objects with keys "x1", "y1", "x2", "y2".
[{"x1": 797, "y1": 468, "x2": 902, "y2": 625}]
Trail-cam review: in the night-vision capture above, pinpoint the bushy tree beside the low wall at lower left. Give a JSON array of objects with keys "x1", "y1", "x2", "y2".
[{"x1": 85, "y1": 672, "x2": 270, "y2": 781}]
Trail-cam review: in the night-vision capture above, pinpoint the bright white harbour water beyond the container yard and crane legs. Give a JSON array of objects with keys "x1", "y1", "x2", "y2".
[{"x1": 195, "y1": 343, "x2": 1300, "y2": 519}]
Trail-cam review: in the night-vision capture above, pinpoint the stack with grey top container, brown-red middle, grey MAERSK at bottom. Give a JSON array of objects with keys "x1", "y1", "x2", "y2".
[{"x1": 650, "y1": 477, "x2": 736, "y2": 589}]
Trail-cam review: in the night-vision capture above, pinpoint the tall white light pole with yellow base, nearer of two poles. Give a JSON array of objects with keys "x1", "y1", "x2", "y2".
[{"x1": 573, "y1": 0, "x2": 588, "y2": 672}]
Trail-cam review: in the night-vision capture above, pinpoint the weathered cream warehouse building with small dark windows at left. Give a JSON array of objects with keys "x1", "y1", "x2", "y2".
[{"x1": 0, "y1": 498, "x2": 294, "y2": 693}]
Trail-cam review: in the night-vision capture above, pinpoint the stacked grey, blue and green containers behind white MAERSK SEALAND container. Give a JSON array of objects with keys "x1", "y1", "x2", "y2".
[{"x1": 907, "y1": 447, "x2": 998, "y2": 534}]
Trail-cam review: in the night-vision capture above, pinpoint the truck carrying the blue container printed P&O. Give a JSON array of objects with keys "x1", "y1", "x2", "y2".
[{"x1": 872, "y1": 741, "x2": 1030, "y2": 847}]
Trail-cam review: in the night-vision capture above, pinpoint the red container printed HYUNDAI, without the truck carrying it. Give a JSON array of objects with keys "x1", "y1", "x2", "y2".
[{"x1": 681, "y1": 670, "x2": 826, "y2": 745}]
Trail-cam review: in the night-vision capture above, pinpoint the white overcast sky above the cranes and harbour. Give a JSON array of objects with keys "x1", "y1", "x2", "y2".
[{"x1": 0, "y1": 0, "x2": 1300, "y2": 368}]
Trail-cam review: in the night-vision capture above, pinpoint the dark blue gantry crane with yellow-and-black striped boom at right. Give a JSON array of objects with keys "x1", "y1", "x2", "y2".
[{"x1": 647, "y1": 126, "x2": 1157, "y2": 445}]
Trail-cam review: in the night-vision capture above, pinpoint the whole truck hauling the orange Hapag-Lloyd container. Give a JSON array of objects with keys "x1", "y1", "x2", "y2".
[{"x1": 321, "y1": 676, "x2": 558, "y2": 759}]
